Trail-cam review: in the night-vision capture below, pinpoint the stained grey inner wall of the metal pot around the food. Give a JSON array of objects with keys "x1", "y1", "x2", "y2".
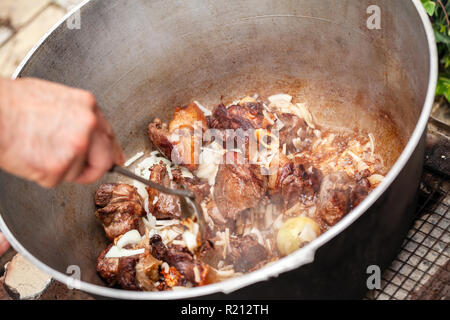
[{"x1": 0, "y1": 0, "x2": 430, "y2": 296}]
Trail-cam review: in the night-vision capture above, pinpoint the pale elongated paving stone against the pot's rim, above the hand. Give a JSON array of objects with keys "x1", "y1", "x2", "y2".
[{"x1": 0, "y1": 5, "x2": 65, "y2": 77}]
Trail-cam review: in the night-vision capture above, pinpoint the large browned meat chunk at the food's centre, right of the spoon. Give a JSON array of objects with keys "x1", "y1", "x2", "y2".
[{"x1": 214, "y1": 152, "x2": 267, "y2": 220}]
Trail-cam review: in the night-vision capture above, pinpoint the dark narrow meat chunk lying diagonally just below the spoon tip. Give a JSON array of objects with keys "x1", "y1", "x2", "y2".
[{"x1": 150, "y1": 235, "x2": 208, "y2": 285}]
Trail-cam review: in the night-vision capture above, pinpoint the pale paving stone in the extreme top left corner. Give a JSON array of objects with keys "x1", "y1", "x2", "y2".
[{"x1": 0, "y1": 0, "x2": 51, "y2": 29}]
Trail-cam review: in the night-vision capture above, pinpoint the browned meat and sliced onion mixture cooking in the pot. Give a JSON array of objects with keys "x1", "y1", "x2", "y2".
[{"x1": 95, "y1": 94, "x2": 385, "y2": 291}]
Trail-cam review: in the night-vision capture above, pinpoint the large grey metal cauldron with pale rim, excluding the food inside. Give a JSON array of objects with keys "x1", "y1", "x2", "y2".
[{"x1": 0, "y1": 0, "x2": 437, "y2": 299}]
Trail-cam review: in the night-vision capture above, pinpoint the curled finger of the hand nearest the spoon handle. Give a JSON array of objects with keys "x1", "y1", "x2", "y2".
[{"x1": 74, "y1": 131, "x2": 113, "y2": 184}]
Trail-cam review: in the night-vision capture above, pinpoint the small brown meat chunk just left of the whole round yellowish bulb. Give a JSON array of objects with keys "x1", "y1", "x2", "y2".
[{"x1": 230, "y1": 235, "x2": 268, "y2": 272}]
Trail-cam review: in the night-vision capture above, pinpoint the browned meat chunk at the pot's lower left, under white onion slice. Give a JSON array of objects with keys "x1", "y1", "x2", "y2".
[{"x1": 97, "y1": 244, "x2": 139, "y2": 290}]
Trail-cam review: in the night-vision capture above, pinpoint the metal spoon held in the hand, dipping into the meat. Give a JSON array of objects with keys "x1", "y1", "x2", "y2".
[{"x1": 110, "y1": 166, "x2": 208, "y2": 243}]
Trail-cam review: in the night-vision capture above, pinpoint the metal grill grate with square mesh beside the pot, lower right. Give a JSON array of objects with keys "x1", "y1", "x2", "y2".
[{"x1": 366, "y1": 171, "x2": 450, "y2": 300}]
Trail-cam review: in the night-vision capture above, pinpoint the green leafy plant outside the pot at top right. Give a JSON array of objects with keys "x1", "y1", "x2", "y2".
[{"x1": 421, "y1": 0, "x2": 450, "y2": 102}]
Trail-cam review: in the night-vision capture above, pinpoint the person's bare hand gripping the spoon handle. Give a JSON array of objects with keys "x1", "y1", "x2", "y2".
[{"x1": 0, "y1": 78, "x2": 125, "y2": 187}]
